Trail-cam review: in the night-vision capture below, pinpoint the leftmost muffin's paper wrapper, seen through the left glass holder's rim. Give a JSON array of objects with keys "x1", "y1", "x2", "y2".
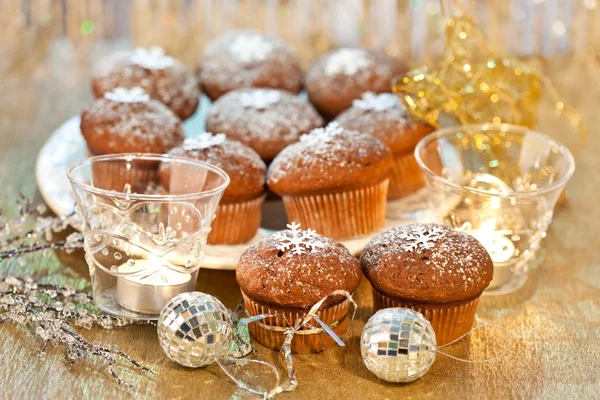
[{"x1": 88, "y1": 149, "x2": 159, "y2": 193}]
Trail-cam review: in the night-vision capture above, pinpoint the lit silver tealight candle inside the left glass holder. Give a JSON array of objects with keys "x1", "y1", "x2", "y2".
[{"x1": 116, "y1": 260, "x2": 195, "y2": 314}]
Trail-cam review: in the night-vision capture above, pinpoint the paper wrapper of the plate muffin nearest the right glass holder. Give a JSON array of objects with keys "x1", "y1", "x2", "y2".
[{"x1": 388, "y1": 152, "x2": 425, "y2": 199}]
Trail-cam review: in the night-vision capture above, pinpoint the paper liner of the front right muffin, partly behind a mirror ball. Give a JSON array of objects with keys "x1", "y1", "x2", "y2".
[{"x1": 373, "y1": 289, "x2": 479, "y2": 346}]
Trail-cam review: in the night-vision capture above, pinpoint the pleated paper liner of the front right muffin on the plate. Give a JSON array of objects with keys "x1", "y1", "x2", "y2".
[{"x1": 283, "y1": 179, "x2": 389, "y2": 240}]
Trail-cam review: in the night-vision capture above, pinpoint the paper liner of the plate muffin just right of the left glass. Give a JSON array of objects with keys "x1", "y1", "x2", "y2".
[{"x1": 208, "y1": 196, "x2": 265, "y2": 244}]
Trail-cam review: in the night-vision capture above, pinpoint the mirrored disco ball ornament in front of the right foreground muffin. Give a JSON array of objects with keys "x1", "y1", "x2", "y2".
[{"x1": 360, "y1": 308, "x2": 437, "y2": 383}]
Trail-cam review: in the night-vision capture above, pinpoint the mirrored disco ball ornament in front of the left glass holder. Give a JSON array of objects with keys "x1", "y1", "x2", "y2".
[{"x1": 158, "y1": 292, "x2": 233, "y2": 368}]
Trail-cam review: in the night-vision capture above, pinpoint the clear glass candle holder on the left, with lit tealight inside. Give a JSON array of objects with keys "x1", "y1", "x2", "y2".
[{"x1": 67, "y1": 154, "x2": 229, "y2": 320}]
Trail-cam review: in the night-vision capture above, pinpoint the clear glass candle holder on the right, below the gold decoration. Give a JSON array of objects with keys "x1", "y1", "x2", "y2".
[{"x1": 415, "y1": 124, "x2": 575, "y2": 294}]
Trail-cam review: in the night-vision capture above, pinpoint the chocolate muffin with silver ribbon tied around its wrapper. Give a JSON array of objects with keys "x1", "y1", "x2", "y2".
[{"x1": 236, "y1": 224, "x2": 361, "y2": 353}]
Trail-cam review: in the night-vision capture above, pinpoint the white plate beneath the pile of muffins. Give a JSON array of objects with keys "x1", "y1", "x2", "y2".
[{"x1": 36, "y1": 101, "x2": 426, "y2": 270}]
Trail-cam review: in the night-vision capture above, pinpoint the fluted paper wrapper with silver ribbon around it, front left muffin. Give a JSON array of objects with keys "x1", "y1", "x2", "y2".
[{"x1": 242, "y1": 292, "x2": 350, "y2": 354}]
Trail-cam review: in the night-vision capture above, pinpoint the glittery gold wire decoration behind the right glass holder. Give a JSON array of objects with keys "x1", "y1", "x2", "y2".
[{"x1": 393, "y1": 0, "x2": 587, "y2": 147}]
